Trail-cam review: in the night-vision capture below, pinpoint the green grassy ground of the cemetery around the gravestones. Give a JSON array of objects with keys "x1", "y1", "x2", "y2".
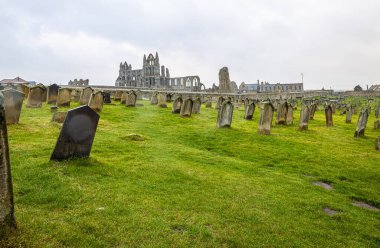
[{"x1": 0, "y1": 101, "x2": 380, "y2": 247}]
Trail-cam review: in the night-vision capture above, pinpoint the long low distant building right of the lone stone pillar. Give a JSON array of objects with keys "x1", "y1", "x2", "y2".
[{"x1": 239, "y1": 80, "x2": 303, "y2": 93}]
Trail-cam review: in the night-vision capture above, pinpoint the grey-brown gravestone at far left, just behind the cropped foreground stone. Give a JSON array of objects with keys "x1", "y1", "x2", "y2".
[{"x1": 3, "y1": 89, "x2": 25, "y2": 125}]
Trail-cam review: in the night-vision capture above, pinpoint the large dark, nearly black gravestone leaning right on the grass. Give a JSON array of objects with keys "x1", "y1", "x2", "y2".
[{"x1": 50, "y1": 106, "x2": 99, "y2": 161}]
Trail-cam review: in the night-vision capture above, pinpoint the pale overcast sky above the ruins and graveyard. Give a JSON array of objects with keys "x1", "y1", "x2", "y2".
[{"x1": 0, "y1": 0, "x2": 380, "y2": 89}]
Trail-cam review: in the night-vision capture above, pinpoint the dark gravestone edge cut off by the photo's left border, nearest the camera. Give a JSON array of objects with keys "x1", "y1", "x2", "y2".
[{"x1": 0, "y1": 93, "x2": 16, "y2": 235}]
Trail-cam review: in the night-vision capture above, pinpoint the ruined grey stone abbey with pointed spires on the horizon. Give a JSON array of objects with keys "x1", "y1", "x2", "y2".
[{"x1": 115, "y1": 53, "x2": 204, "y2": 91}]
